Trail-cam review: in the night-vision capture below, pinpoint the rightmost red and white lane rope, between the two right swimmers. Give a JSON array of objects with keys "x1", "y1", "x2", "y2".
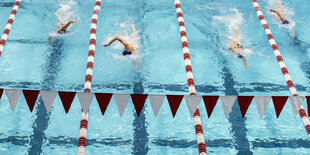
[{"x1": 252, "y1": 0, "x2": 310, "y2": 137}]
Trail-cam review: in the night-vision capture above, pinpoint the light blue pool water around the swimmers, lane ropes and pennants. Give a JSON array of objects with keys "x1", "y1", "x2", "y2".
[{"x1": 0, "y1": 0, "x2": 310, "y2": 155}]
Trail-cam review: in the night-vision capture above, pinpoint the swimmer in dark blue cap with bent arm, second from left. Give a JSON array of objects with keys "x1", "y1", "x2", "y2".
[{"x1": 102, "y1": 25, "x2": 140, "y2": 66}]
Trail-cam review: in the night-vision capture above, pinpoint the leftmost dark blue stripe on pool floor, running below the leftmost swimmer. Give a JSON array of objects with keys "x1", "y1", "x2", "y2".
[{"x1": 28, "y1": 38, "x2": 64, "y2": 155}]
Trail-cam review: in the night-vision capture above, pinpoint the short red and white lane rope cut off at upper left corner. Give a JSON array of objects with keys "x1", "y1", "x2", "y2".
[{"x1": 0, "y1": 0, "x2": 21, "y2": 56}]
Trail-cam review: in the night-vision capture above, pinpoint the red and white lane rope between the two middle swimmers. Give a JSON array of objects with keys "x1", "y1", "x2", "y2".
[{"x1": 174, "y1": 0, "x2": 207, "y2": 155}]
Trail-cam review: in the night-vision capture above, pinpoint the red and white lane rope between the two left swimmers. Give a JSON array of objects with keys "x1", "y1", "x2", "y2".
[{"x1": 78, "y1": 0, "x2": 101, "y2": 155}]
